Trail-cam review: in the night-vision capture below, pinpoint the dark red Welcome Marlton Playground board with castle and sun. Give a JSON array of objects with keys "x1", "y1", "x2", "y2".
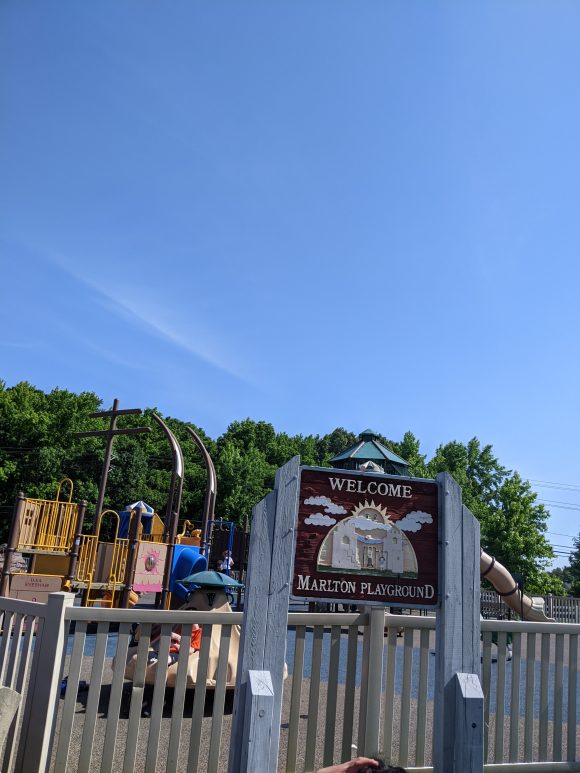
[{"x1": 292, "y1": 467, "x2": 439, "y2": 608}]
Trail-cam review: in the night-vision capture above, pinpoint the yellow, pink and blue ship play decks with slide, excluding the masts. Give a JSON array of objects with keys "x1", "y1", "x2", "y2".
[{"x1": 0, "y1": 479, "x2": 207, "y2": 607}]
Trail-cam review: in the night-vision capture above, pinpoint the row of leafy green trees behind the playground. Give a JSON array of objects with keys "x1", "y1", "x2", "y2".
[{"x1": 0, "y1": 381, "x2": 568, "y2": 594}]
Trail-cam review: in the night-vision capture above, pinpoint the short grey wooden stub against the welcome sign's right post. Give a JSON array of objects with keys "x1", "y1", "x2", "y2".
[{"x1": 454, "y1": 673, "x2": 483, "y2": 771}]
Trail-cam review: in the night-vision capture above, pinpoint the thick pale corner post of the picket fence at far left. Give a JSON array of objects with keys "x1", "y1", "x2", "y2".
[{"x1": 15, "y1": 592, "x2": 75, "y2": 773}]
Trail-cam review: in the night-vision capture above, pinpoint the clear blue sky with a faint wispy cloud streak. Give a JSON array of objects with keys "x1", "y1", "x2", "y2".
[{"x1": 0, "y1": 0, "x2": 580, "y2": 568}]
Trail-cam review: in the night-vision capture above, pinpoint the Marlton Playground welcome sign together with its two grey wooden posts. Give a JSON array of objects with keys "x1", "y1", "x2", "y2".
[{"x1": 229, "y1": 457, "x2": 483, "y2": 773}]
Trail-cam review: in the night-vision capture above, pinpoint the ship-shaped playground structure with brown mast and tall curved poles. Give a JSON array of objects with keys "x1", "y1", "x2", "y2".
[{"x1": 0, "y1": 400, "x2": 217, "y2": 609}]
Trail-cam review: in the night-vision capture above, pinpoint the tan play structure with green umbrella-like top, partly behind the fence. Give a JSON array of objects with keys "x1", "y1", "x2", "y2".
[{"x1": 125, "y1": 571, "x2": 241, "y2": 689}]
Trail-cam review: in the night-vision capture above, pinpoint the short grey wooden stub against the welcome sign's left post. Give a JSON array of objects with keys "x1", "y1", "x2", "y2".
[{"x1": 240, "y1": 671, "x2": 274, "y2": 771}]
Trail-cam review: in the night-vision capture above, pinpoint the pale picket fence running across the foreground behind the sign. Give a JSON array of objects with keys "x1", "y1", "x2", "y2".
[{"x1": 0, "y1": 594, "x2": 580, "y2": 773}]
